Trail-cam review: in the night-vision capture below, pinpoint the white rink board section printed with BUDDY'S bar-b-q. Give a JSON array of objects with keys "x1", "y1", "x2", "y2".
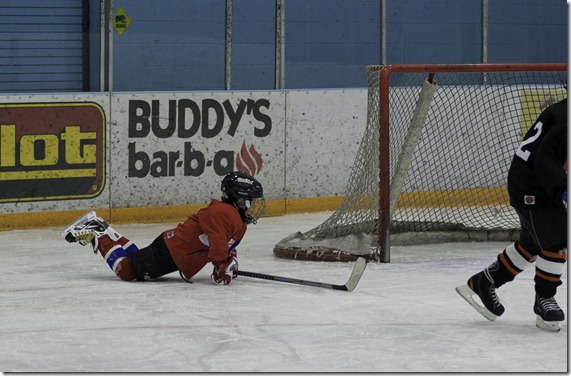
[{"x1": 110, "y1": 92, "x2": 284, "y2": 206}]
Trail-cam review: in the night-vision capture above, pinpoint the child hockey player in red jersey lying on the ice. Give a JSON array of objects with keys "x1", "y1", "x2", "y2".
[{"x1": 62, "y1": 172, "x2": 265, "y2": 285}]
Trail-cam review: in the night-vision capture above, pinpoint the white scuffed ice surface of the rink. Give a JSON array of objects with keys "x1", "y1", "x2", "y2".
[{"x1": 0, "y1": 213, "x2": 569, "y2": 373}]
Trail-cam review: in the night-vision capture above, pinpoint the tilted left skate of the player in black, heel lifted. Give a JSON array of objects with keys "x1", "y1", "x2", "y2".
[{"x1": 456, "y1": 269, "x2": 505, "y2": 321}]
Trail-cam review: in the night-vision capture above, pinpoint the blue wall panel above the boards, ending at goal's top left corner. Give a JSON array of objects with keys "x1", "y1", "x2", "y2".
[{"x1": 285, "y1": 0, "x2": 381, "y2": 88}]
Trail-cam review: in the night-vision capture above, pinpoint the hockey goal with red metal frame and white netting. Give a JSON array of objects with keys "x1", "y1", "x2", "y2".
[{"x1": 274, "y1": 64, "x2": 567, "y2": 262}]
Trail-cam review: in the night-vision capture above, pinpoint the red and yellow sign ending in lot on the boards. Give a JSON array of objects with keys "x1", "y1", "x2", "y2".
[{"x1": 0, "y1": 103, "x2": 105, "y2": 202}]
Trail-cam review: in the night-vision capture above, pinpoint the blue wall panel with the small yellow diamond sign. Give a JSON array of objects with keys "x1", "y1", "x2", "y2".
[{"x1": 113, "y1": 0, "x2": 225, "y2": 91}]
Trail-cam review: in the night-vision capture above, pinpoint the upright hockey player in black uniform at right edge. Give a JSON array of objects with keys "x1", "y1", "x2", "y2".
[{"x1": 456, "y1": 99, "x2": 567, "y2": 331}]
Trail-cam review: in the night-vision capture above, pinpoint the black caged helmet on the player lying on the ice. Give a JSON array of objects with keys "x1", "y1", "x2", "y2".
[{"x1": 220, "y1": 171, "x2": 266, "y2": 224}]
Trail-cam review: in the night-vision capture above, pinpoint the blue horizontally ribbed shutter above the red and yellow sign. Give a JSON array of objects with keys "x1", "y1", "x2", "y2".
[{"x1": 0, "y1": 0, "x2": 89, "y2": 92}]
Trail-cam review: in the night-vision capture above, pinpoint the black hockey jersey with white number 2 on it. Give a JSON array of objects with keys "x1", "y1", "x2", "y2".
[{"x1": 508, "y1": 98, "x2": 567, "y2": 210}]
